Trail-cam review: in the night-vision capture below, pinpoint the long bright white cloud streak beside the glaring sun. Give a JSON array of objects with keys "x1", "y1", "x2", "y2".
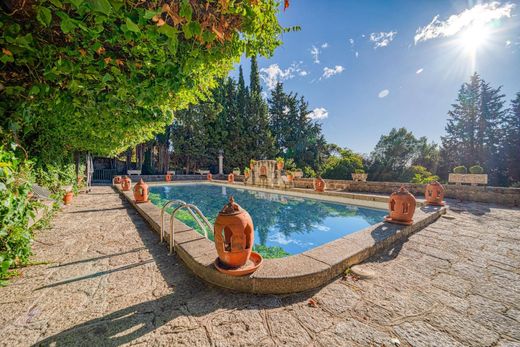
[{"x1": 414, "y1": 1, "x2": 515, "y2": 44}]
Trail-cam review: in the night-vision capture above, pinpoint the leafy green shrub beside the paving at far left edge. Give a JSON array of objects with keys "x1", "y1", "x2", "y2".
[{"x1": 0, "y1": 147, "x2": 36, "y2": 285}]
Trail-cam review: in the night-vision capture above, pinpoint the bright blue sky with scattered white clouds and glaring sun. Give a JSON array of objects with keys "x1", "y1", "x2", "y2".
[{"x1": 230, "y1": 0, "x2": 520, "y2": 154}]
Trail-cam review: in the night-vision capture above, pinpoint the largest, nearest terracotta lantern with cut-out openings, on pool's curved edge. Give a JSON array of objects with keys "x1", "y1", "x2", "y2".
[{"x1": 213, "y1": 197, "x2": 255, "y2": 268}]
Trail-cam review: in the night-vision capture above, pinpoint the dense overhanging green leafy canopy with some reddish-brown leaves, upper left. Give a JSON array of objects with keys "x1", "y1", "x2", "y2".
[{"x1": 0, "y1": 0, "x2": 284, "y2": 162}]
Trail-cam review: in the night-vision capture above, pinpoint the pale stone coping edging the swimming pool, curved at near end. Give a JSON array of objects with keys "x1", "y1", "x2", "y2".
[{"x1": 114, "y1": 182, "x2": 446, "y2": 294}]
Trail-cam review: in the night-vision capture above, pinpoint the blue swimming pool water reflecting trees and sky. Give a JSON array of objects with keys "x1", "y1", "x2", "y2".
[{"x1": 150, "y1": 184, "x2": 387, "y2": 258}]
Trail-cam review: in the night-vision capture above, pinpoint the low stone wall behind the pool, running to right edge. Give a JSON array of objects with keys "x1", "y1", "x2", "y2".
[{"x1": 294, "y1": 178, "x2": 520, "y2": 206}]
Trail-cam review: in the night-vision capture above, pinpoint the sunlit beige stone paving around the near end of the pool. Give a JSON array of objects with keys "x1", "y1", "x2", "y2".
[{"x1": 0, "y1": 187, "x2": 520, "y2": 346}]
